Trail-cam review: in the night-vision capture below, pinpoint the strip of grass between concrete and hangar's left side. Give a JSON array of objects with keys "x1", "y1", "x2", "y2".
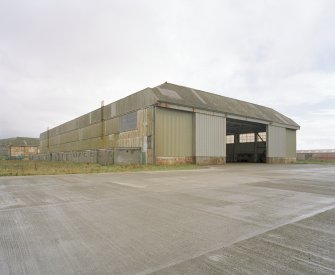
[{"x1": 0, "y1": 160, "x2": 199, "y2": 176}]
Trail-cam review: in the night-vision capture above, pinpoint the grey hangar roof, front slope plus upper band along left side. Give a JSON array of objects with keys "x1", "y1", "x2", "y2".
[{"x1": 40, "y1": 82, "x2": 299, "y2": 138}]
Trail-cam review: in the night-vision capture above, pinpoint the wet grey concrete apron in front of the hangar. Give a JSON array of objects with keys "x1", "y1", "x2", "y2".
[{"x1": 0, "y1": 164, "x2": 335, "y2": 274}]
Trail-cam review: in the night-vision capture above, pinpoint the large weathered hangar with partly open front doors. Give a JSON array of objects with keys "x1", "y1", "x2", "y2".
[{"x1": 40, "y1": 82, "x2": 299, "y2": 164}]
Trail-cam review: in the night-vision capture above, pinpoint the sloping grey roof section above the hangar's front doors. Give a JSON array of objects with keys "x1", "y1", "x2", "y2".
[{"x1": 150, "y1": 82, "x2": 299, "y2": 128}]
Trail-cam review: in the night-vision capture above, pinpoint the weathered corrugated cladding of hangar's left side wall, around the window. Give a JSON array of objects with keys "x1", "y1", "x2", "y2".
[{"x1": 40, "y1": 89, "x2": 156, "y2": 153}]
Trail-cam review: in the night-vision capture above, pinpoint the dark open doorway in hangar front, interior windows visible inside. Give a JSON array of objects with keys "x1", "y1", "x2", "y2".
[{"x1": 226, "y1": 118, "x2": 266, "y2": 163}]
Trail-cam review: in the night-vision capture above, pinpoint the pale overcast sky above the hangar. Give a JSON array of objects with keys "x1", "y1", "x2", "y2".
[{"x1": 0, "y1": 0, "x2": 335, "y2": 149}]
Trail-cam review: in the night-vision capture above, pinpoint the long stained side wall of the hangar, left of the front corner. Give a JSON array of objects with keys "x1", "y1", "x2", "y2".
[{"x1": 39, "y1": 89, "x2": 155, "y2": 164}]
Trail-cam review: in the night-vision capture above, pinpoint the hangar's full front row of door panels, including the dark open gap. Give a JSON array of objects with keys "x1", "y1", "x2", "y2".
[{"x1": 154, "y1": 107, "x2": 296, "y2": 164}]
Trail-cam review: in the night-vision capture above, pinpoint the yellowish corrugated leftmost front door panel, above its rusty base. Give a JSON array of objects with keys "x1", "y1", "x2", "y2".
[{"x1": 155, "y1": 108, "x2": 193, "y2": 157}]
